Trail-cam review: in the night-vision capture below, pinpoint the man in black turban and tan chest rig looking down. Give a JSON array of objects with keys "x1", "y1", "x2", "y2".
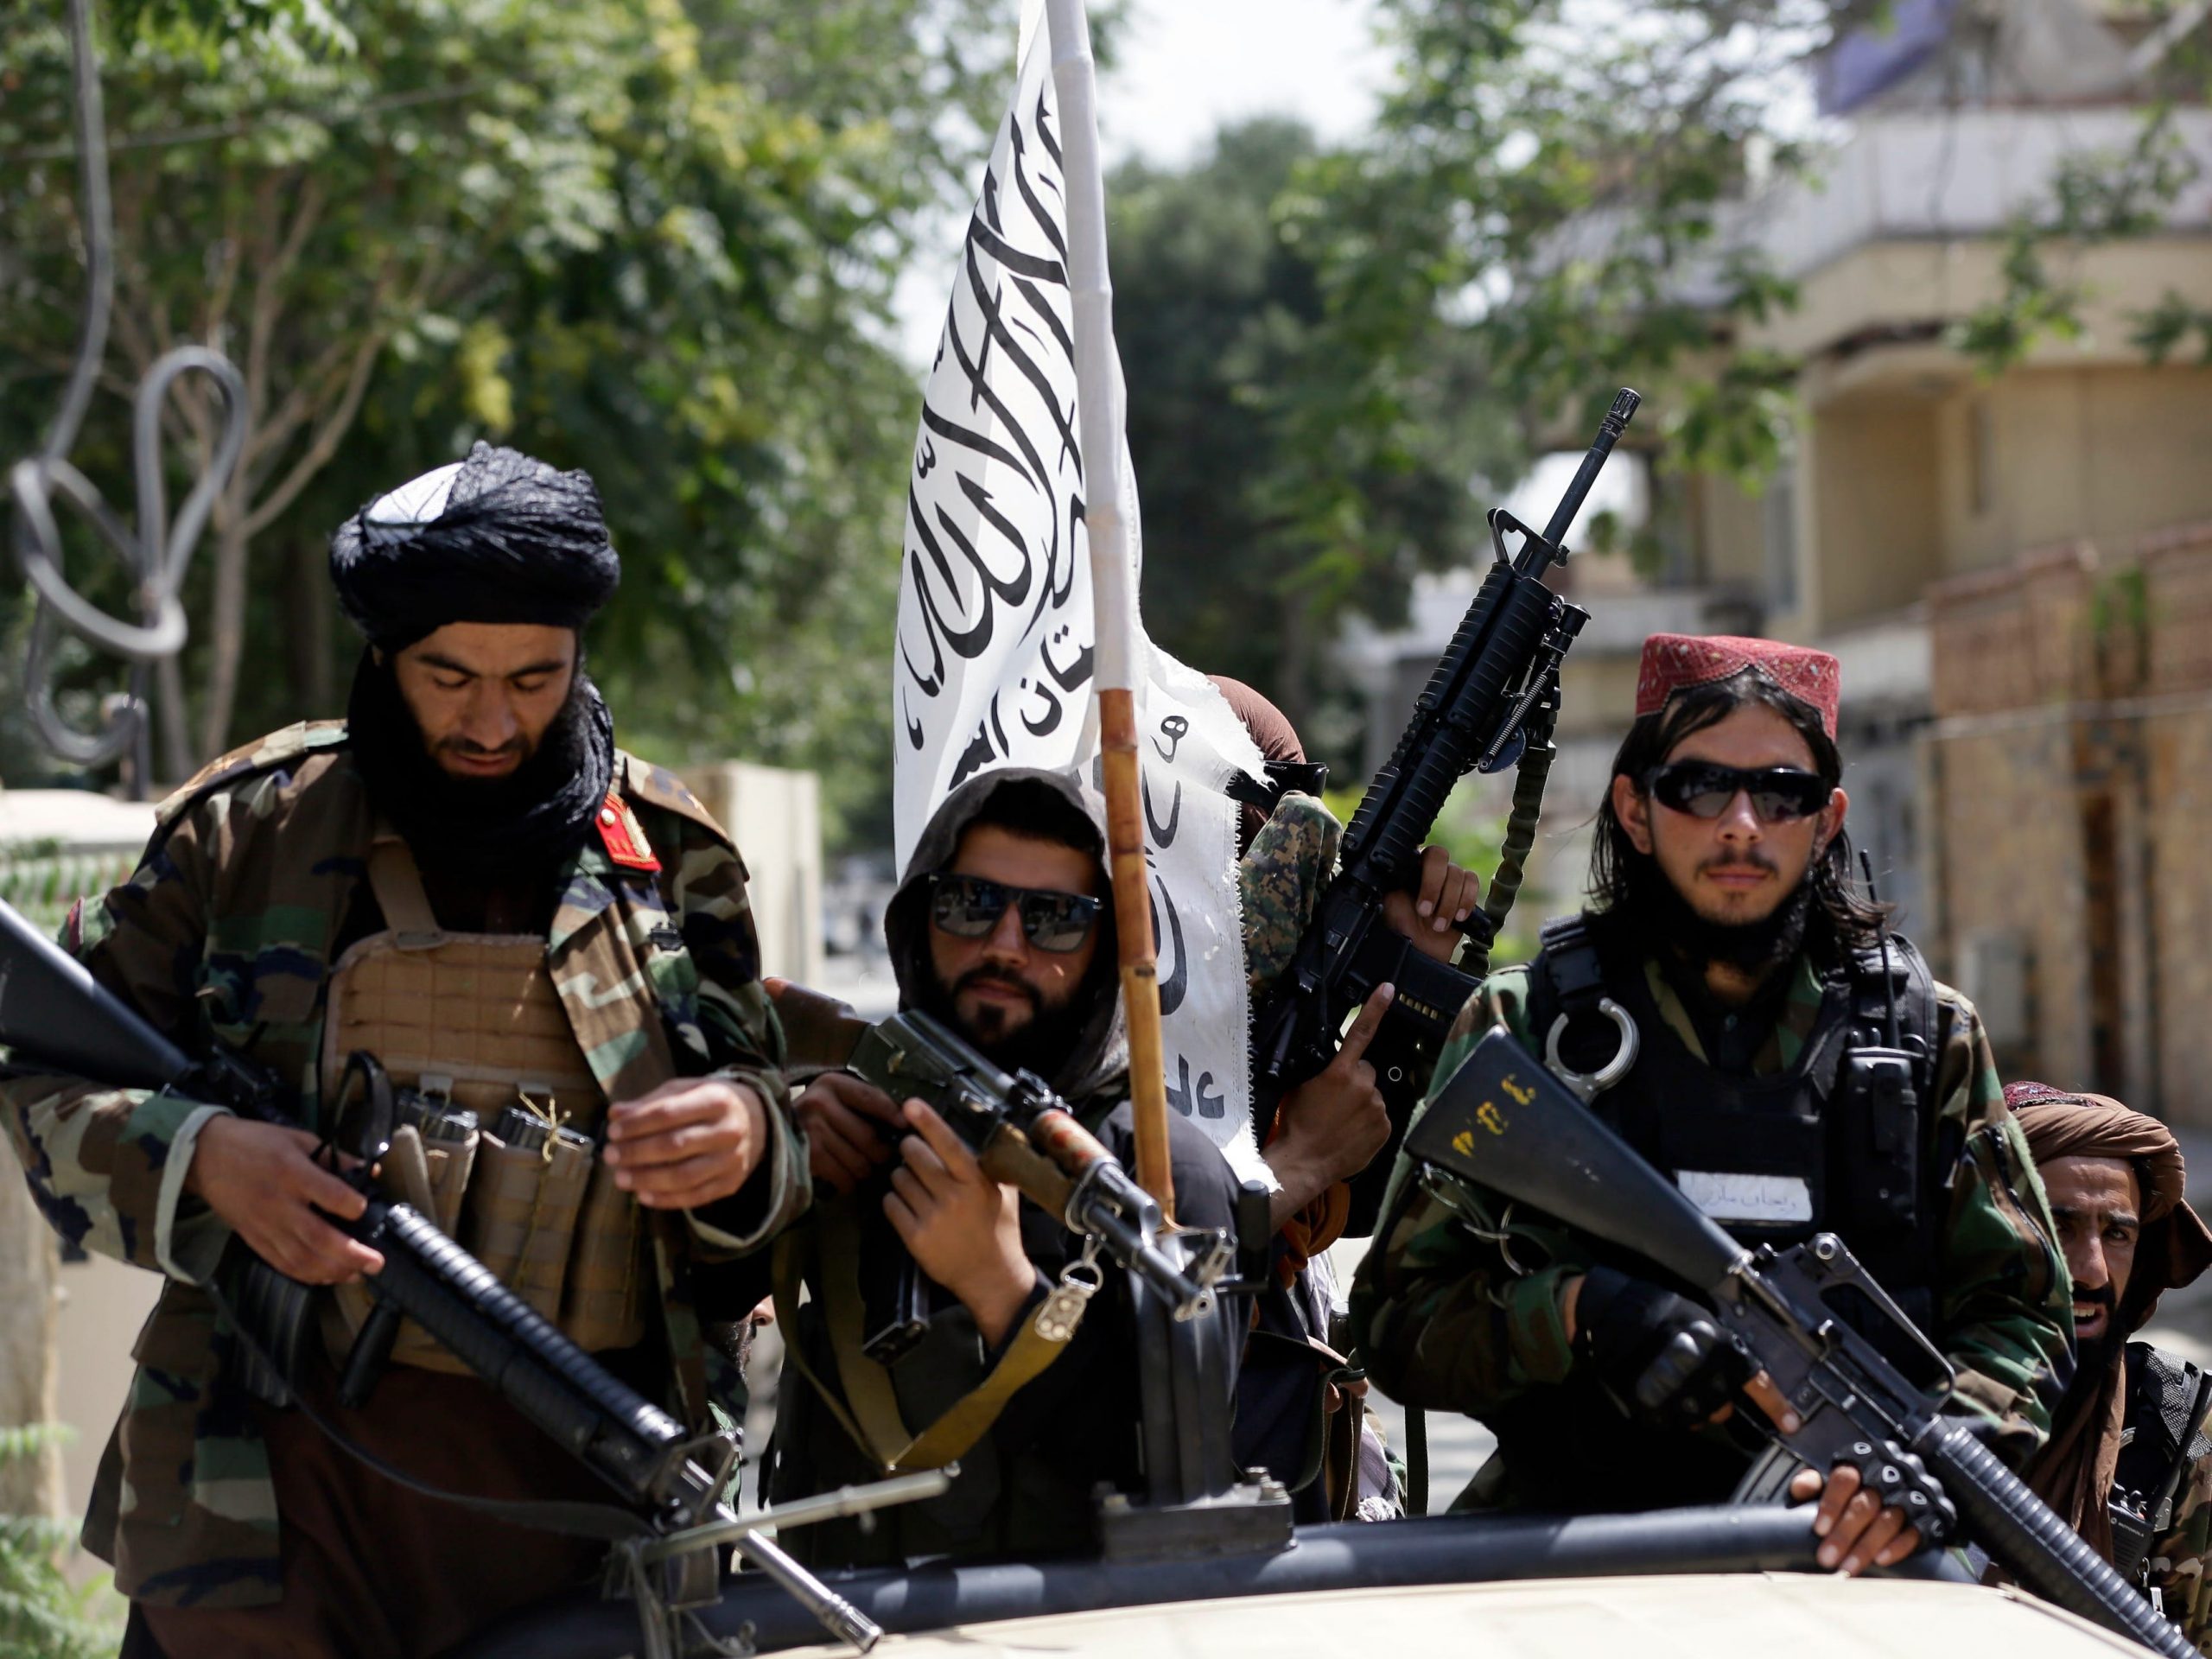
[{"x1": 4, "y1": 445, "x2": 807, "y2": 1659}]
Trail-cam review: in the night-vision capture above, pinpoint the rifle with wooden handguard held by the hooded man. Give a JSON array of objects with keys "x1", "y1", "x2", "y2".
[{"x1": 845, "y1": 1013, "x2": 1232, "y2": 1365}]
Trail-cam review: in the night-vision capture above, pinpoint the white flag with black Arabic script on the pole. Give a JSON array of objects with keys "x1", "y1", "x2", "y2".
[{"x1": 892, "y1": 13, "x2": 1263, "y2": 1173}]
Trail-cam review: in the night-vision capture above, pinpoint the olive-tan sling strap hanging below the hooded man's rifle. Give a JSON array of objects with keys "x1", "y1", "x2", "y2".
[{"x1": 774, "y1": 1204, "x2": 1079, "y2": 1476}]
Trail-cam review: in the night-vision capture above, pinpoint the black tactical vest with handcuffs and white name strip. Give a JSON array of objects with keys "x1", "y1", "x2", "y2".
[{"x1": 1529, "y1": 916, "x2": 1960, "y2": 1344}]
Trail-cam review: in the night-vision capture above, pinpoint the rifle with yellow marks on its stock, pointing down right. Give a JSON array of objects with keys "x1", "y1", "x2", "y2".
[{"x1": 1405, "y1": 1031, "x2": 2196, "y2": 1659}]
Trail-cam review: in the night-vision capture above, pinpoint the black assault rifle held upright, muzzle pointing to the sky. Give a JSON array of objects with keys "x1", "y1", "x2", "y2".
[{"x1": 1252, "y1": 387, "x2": 1642, "y2": 1234}]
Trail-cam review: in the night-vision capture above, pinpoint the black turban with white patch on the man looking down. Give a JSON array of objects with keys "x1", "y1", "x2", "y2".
[{"x1": 329, "y1": 442, "x2": 621, "y2": 651}]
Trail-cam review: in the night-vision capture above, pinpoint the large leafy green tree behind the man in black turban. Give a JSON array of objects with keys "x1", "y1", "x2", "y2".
[{"x1": 0, "y1": 0, "x2": 1013, "y2": 844}]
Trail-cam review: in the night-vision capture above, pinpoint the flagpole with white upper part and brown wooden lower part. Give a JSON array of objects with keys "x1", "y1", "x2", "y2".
[{"x1": 1044, "y1": 0, "x2": 1174, "y2": 1217}]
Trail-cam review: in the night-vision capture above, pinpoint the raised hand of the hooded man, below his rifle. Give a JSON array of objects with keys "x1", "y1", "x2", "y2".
[{"x1": 882, "y1": 1099, "x2": 1038, "y2": 1347}]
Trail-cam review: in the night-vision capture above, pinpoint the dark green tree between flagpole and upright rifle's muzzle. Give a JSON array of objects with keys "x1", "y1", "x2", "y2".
[{"x1": 1106, "y1": 119, "x2": 1513, "y2": 747}]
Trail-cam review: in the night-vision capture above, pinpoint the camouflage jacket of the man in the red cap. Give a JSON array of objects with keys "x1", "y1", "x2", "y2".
[{"x1": 1351, "y1": 929, "x2": 2073, "y2": 1500}]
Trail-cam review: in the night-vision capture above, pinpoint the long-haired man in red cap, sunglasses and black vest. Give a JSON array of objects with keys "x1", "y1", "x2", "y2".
[{"x1": 1351, "y1": 635, "x2": 2066, "y2": 1573}]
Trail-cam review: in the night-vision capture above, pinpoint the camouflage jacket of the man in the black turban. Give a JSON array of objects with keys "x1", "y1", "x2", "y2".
[{"x1": 0, "y1": 721, "x2": 807, "y2": 1606}]
